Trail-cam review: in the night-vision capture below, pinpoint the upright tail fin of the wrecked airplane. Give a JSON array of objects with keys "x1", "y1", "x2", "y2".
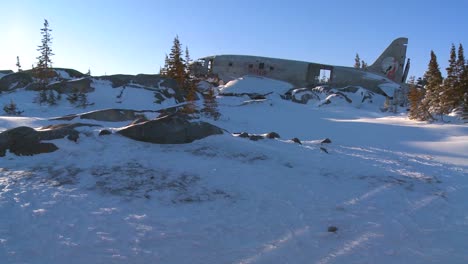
[{"x1": 367, "y1": 38, "x2": 408, "y2": 83}]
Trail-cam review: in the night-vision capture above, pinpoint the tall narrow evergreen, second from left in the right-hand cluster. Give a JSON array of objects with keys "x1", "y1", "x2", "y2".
[{"x1": 439, "y1": 44, "x2": 459, "y2": 115}]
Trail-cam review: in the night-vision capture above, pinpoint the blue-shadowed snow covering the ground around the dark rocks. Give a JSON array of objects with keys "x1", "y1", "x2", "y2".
[{"x1": 0, "y1": 77, "x2": 468, "y2": 264}]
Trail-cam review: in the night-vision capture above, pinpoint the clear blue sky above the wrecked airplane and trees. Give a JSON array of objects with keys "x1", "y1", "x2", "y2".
[{"x1": 0, "y1": 0, "x2": 468, "y2": 76}]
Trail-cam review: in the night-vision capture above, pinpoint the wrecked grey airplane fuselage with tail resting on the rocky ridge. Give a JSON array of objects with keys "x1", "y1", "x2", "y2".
[{"x1": 192, "y1": 38, "x2": 410, "y2": 97}]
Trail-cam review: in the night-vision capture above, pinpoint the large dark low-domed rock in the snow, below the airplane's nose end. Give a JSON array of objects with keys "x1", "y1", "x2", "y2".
[{"x1": 117, "y1": 115, "x2": 223, "y2": 144}]
